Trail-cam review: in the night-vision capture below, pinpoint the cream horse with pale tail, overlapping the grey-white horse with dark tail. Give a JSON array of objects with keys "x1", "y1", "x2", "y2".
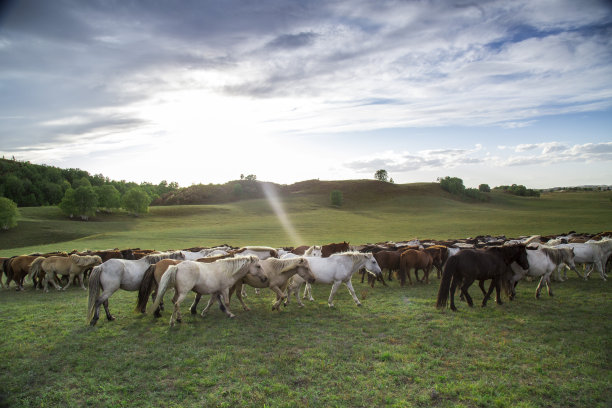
[{"x1": 153, "y1": 255, "x2": 268, "y2": 326}]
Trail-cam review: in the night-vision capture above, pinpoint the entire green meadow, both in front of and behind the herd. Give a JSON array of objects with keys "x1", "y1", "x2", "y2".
[{"x1": 0, "y1": 185, "x2": 612, "y2": 407}]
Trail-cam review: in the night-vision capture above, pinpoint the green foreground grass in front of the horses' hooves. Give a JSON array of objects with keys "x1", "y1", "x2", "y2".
[{"x1": 0, "y1": 277, "x2": 612, "y2": 407}]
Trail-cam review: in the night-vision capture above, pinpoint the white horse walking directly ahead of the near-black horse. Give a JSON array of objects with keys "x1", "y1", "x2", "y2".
[{"x1": 510, "y1": 245, "x2": 578, "y2": 298}]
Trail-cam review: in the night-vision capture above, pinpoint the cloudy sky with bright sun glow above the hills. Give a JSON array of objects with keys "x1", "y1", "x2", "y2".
[{"x1": 0, "y1": 0, "x2": 612, "y2": 188}]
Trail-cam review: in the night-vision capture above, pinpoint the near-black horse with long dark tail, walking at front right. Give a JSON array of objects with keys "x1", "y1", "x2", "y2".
[{"x1": 436, "y1": 245, "x2": 529, "y2": 311}]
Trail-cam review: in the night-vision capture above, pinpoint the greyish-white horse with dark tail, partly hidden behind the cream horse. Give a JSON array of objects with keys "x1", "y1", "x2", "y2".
[{"x1": 87, "y1": 251, "x2": 184, "y2": 326}]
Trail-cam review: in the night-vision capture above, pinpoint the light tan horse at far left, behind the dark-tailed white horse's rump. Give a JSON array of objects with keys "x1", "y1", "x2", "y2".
[{"x1": 30, "y1": 254, "x2": 102, "y2": 292}]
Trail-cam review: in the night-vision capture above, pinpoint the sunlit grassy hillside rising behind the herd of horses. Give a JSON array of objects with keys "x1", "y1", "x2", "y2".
[{"x1": 0, "y1": 180, "x2": 612, "y2": 256}]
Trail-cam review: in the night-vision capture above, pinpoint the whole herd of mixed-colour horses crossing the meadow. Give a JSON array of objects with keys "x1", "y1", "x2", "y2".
[{"x1": 0, "y1": 233, "x2": 612, "y2": 326}]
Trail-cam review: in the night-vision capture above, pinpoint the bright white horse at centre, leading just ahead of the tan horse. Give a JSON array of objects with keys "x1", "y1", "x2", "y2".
[{"x1": 285, "y1": 252, "x2": 382, "y2": 307}]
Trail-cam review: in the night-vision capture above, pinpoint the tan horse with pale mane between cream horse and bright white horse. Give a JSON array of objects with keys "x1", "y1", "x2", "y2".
[{"x1": 229, "y1": 257, "x2": 315, "y2": 311}]
